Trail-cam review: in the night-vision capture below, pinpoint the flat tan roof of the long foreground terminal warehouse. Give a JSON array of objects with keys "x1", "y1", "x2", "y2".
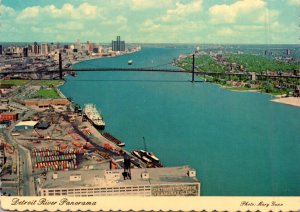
[{"x1": 40, "y1": 166, "x2": 200, "y2": 189}]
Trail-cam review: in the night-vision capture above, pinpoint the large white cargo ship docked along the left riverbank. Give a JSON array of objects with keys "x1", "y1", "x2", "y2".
[{"x1": 83, "y1": 104, "x2": 105, "y2": 130}]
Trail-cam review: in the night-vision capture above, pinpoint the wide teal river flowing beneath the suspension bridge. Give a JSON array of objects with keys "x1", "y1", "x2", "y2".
[{"x1": 61, "y1": 47, "x2": 300, "y2": 196}]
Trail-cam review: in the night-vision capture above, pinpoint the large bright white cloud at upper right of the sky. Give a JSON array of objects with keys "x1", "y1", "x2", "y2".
[{"x1": 209, "y1": 0, "x2": 266, "y2": 23}]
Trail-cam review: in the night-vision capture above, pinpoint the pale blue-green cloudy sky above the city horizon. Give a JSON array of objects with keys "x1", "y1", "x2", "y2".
[{"x1": 0, "y1": 0, "x2": 300, "y2": 44}]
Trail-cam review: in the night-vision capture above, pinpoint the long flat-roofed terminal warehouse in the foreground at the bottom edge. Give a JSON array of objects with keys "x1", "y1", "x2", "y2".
[{"x1": 38, "y1": 166, "x2": 200, "y2": 196}]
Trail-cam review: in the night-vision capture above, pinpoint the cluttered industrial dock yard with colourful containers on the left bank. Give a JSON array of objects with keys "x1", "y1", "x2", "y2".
[{"x1": 1, "y1": 81, "x2": 162, "y2": 196}]
